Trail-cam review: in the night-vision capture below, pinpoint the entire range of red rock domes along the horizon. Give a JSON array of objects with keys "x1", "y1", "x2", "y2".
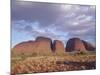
[{"x1": 12, "y1": 37, "x2": 95, "y2": 55}]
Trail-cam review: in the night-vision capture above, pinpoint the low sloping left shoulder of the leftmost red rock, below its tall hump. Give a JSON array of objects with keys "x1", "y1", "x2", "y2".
[{"x1": 13, "y1": 41, "x2": 36, "y2": 54}]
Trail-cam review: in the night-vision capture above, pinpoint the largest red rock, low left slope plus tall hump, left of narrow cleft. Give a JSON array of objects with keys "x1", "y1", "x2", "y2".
[{"x1": 13, "y1": 37, "x2": 52, "y2": 55}]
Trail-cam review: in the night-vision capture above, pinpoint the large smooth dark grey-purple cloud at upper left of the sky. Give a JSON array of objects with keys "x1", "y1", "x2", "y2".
[{"x1": 11, "y1": 1, "x2": 65, "y2": 25}]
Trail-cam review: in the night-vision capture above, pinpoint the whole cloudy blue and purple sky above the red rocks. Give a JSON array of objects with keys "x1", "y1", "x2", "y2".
[{"x1": 11, "y1": 0, "x2": 96, "y2": 46}]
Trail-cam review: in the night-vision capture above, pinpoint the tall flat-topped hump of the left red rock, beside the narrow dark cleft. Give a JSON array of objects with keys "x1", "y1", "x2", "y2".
[{"x1": 36, "y1": 37, "x2": 52, "y2": 54}]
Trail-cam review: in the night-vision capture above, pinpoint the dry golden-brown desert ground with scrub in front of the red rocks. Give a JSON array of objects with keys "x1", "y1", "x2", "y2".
[{"x1": 11, "y1": 51, "x2": 96, "y2": 75}]
